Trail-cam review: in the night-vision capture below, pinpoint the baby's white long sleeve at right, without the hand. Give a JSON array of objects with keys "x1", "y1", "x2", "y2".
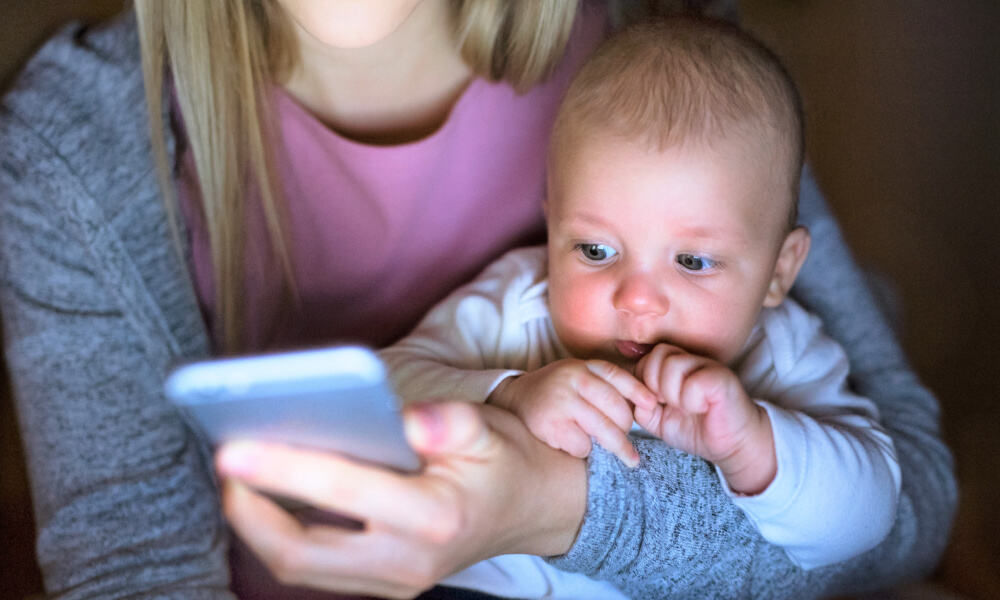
[{"x1": 734, "y1": 300, "x2": 901, "y2": 568}]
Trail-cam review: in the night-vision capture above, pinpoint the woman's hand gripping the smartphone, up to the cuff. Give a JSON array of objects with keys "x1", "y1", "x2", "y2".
[{"x1": 216, "y1": 402, "x2": 587, "y2": 598}]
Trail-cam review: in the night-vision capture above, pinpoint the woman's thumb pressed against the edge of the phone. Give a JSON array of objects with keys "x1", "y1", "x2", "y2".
[{"x1": 403, "y1": 402, "x2": 492, "y2": 456}]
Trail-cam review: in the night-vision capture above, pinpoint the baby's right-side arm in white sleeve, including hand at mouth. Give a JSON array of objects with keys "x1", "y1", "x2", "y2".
[{"x1": 636, "y1": 303, "x2": 900, "y2": 568}]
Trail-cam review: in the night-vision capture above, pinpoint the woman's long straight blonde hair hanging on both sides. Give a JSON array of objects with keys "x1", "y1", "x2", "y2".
[{"x1": 135, "y1": 0, "x2": 578, "y2": 352}]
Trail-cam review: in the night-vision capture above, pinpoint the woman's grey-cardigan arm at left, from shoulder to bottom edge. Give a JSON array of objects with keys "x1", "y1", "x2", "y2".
[{"x1": 0, "y1": 21, "x2": 231, "y2": 598}]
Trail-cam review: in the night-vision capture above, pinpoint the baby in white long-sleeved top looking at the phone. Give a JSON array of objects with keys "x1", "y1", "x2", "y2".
[{"x1": 382, "y1": 18, "x2": 900, "y2": 597}]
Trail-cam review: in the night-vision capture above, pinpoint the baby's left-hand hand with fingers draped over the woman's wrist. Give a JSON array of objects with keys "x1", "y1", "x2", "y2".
[{"x1": 488, "y1": 359, "x2": 657, "y2": 467}]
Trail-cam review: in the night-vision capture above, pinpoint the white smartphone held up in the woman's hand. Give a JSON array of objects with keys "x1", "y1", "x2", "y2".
[{"x1": 164, "y1": 346, "x2": 421, "y2": 472}]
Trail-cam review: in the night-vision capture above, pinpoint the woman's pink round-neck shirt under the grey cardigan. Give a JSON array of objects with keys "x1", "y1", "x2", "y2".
[{"x1": 178, "y1": 4, "x2": 605, "y2": 350}]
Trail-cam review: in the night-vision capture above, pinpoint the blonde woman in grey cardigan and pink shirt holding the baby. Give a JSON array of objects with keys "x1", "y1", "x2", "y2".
[{"x1": 0, "y1": 0, "x2": 955, "y2": 597}]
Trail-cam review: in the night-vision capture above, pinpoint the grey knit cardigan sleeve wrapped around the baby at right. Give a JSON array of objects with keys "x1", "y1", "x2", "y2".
[{"x1": 551, "y1": 166, "x2": 957, "y2": 598}]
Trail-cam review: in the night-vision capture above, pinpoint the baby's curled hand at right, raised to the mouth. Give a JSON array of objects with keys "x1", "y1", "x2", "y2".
[{"x1": 635, "y1": 344, "x2": 777, "y2": 494}]
